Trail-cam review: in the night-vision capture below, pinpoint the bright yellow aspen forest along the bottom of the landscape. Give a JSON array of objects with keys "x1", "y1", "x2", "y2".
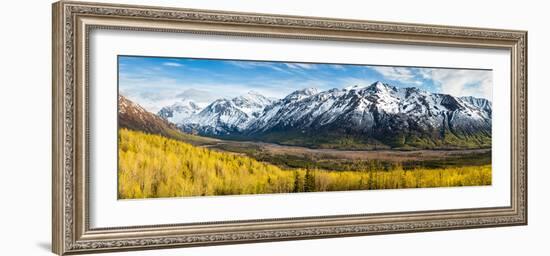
[{"x1": 118, "y1": 129, "x2": 491, "y2": 199}]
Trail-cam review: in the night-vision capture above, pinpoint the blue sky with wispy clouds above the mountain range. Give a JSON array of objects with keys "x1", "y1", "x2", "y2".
[{"x1": 118, "y1": 56, "x2": 493, "y2": 112}]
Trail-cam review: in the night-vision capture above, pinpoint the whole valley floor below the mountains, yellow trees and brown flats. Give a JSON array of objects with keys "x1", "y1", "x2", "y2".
[{"x1": 118, "y1": 129, "x2": 491, "y2": 199}]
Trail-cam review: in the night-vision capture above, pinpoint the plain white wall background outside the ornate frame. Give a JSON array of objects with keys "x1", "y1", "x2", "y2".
[{"x1": 0, "y1": 0, "x2": 550, "y2": 256}]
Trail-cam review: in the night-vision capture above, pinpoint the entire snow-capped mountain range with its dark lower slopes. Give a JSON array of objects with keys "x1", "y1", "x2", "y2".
[{"x1": 118, "y1": 82, "x2": 492, "y2": 149}]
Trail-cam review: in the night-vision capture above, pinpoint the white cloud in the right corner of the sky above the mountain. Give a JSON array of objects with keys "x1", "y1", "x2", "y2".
[{"x1": 419, "y1": 69, "x2": 493, "y2": 100}]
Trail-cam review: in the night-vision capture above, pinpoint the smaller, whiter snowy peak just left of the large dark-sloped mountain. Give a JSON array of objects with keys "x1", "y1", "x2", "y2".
[{"x1": 177, "y1": 91, "x2": 273, "y2": 135}]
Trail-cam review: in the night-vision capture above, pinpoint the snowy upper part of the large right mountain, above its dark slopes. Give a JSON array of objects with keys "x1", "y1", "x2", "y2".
[{"x1": 249, "y1": 82, "x2": 491, "y2": 133}]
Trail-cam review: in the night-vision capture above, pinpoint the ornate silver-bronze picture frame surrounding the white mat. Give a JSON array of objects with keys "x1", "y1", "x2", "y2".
[{"x1": 52, "y1": 1, "x2": 527, "y2": 255}]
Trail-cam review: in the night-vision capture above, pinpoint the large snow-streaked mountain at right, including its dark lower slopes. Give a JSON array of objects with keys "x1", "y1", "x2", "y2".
[{"x1": 252, "y1": 82, "x2": 492, "y2": 147}]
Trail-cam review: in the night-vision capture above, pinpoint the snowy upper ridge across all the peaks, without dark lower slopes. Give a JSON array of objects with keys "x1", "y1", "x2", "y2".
[{"x1": 157, "y1": 81, "x2": 491, "y2": 134}]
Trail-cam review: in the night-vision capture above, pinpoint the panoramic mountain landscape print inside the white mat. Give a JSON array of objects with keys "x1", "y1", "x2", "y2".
[{"x1": 117, "y1": 56, "x2": 493, "y2": 199}]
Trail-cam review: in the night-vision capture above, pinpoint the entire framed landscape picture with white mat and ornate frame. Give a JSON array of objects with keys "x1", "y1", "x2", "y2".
[{"x1": 52, "y1": 1, "x2": 527, "y2": 255}]
